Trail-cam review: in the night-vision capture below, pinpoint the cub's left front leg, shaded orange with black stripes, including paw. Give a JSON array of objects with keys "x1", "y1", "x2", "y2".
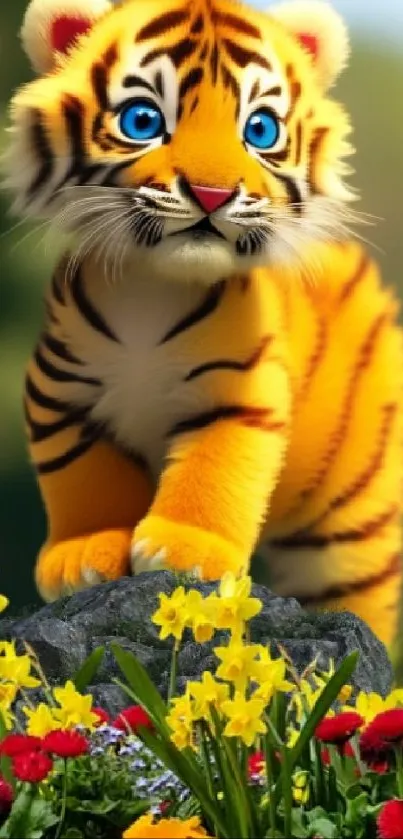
[{"x1": 26, "y1": 366, "x2": 152, "y2": 600}]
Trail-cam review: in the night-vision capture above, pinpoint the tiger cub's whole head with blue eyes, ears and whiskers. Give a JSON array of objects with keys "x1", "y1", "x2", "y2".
[{"x1": 7, "y1": 0, "x2": 354, "y2": 282}]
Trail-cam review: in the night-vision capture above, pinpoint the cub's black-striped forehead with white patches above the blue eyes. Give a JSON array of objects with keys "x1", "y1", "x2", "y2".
[{"x1": 109, "y1": 7, "x2": 290, "y2": 122}]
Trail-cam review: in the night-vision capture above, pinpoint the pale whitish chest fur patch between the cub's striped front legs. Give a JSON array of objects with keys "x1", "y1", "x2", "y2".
[{"x1": 80, "y1": 274, "x2": 215, "y2": 477}]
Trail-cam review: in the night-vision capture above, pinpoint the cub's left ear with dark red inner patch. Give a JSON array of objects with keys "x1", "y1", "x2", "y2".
[{"x1": 21, "y1": 0, "x2": 112, "y2": 73}]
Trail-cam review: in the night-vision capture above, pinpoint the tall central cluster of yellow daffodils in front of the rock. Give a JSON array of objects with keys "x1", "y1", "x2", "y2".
[{"x1": 152, "y1": 574, "x2": 295, "y2": 749}]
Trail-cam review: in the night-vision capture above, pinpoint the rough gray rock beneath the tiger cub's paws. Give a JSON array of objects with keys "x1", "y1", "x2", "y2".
[{"x1": 0, "y1": 572, "x2": 392, "y2": 713}]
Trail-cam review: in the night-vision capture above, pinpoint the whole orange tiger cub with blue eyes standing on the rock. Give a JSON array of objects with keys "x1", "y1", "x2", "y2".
[{"x1": 6, "y1": 0, "x2": 403, "y2": 643}]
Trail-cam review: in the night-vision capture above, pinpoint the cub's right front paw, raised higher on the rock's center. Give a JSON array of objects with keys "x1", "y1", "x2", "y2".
[{"x1": 131, "y1": 515, "x2": 249, "y2": 580}]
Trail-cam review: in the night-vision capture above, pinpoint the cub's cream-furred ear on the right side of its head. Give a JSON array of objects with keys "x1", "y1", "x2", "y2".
[{"x1": 267, "y1": 0, "x2": 350, "y2": 90}]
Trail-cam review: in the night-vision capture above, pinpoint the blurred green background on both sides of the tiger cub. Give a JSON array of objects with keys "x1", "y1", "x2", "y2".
[{"x1": 0, "y1": 0, "x2": 403, "y2": 632}]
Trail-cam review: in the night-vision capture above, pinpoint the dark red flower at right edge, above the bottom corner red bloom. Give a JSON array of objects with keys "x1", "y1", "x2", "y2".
[{"x1": 360, "y1": 708, "x2": 403, "y2": 771}]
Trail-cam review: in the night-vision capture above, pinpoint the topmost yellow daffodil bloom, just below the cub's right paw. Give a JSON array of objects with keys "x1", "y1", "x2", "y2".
[{"x1": 216, "y1": 572, "x2": 262, "y2": 636}]
